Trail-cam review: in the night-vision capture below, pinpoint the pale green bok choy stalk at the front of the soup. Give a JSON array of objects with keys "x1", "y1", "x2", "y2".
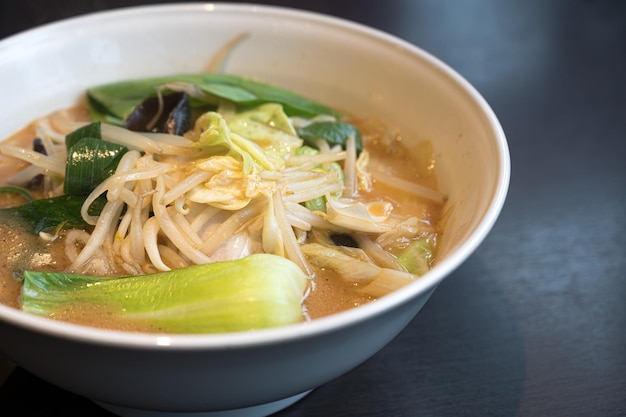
[{"x1": 22, "y1": 254, "x2": 307, "y2": 333}]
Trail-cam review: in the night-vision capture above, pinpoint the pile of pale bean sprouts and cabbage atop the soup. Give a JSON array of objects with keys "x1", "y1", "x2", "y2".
[{"x1": 0, "y1": 104, "x2": 445, "y2": 298}]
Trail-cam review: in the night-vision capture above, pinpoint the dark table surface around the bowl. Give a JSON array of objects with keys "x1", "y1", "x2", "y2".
[{"x1": 0, "y1": 0, "x2": 626, "y2": 417}]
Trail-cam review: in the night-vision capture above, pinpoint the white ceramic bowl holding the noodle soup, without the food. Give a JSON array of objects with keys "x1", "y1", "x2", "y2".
[{"x1": 0, "y1": 4, "x2": 510, "y2": 417}]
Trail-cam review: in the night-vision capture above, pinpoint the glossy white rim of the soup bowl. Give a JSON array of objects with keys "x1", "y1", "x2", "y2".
[{"x1": 0, "y1": 2, "x2": 511, "y2": 350}]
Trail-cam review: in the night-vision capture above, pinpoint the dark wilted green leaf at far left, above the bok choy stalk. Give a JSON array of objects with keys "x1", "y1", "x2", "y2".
[{"x1": 0, "y1": 195, "x2": 106, "y2": 234}]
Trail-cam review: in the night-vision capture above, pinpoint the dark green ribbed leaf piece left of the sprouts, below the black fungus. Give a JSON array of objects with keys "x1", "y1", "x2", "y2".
[{"x1": 63, "y1": 122, "x2": 128, "y2": 194}]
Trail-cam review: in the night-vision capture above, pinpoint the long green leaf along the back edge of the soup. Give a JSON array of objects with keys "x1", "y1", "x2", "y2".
[{"x1": 87, "y1": 73, "x2": 342, "y2": 124}]
